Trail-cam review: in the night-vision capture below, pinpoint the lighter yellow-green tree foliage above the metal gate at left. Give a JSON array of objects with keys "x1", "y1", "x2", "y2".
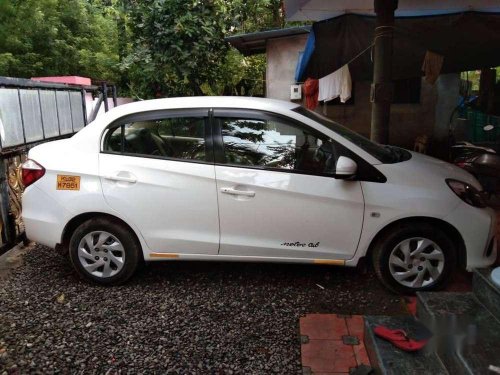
[{"x1": 0, "y1": 0, "x2": 119, "y2": 80}]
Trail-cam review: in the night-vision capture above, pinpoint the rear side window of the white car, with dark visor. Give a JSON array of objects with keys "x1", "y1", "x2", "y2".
[{"x1": 104, "y1": 117, "x2": 206, "y2": 160}]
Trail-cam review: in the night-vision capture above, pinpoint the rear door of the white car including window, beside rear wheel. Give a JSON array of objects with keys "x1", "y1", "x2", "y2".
[{"x1": 99, "y1": 110, "x2": 219, "y2": 254}]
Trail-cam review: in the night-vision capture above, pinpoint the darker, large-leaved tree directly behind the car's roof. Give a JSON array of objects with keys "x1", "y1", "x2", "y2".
[{"x1": 121, "y1": 0, "x2": 284, "y2": 98}]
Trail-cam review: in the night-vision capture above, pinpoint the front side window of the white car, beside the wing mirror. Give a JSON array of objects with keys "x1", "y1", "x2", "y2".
[{"x1": 219, "y1": 117, "x2": 338, "y2": 174}]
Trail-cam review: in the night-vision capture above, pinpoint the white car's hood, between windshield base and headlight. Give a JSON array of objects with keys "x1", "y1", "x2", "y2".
[{"x1": 377, "y1": 151, "x2": 482, "y2": 190}]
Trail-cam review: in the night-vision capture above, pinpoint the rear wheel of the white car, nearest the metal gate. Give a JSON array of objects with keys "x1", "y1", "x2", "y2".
[{"x1": 69, "y1": 218, "x2": 141, "y2": 285}]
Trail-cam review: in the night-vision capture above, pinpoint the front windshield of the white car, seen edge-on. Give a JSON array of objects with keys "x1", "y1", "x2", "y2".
[{"x1": 293, "y1": 107, "x2": 411, "y2": 164}]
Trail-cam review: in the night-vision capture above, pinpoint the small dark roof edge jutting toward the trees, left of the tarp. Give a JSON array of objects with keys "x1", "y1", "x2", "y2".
[{"x1": 224, "y1": 26, "x2": 311, "y2": 56}]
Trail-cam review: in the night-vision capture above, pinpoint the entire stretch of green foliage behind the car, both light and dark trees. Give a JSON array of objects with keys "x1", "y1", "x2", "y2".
[{"x1": 0, "y1": 0, "x2": 284, "y2": 98}]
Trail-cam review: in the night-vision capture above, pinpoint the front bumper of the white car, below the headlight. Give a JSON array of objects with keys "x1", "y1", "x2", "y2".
[{"x1": 445, "y1": 203, "x2": 497, "y2": 271}]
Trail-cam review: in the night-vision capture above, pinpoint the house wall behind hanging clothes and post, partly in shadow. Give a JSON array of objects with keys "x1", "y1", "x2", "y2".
[{"x1": 266, "y1": 35, "x2": 437, "y2": 149}]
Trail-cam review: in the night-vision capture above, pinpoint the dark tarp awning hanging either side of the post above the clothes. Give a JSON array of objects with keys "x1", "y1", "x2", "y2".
[{"x1": 300, "y1": 12, "x2": 500, "y2": 80}]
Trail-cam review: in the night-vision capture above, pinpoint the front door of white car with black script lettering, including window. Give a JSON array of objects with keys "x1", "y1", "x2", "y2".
[{"x1": 214, "y1": 109, "x2": 364, "y2": 259}]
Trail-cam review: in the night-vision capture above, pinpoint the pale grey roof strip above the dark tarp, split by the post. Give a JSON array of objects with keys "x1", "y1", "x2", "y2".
[{"x1": 284, "y1": 0, "x2": 500, "y2": 21}]
